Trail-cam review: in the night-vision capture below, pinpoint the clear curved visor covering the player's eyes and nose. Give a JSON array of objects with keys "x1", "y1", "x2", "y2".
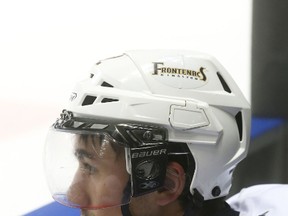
[{"x1": 45, "y1": 128, "x2": 131, "y2": 209}]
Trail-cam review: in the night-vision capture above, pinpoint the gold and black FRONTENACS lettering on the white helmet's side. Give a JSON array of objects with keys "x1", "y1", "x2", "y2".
[{"x1": 152, "y1": 62, "x2": 207, "y2": 82}]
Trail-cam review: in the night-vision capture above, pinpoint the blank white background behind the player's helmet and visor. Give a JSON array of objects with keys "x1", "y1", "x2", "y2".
[{"x1": 0, "y1": 0, "x2": 252, "y2": 216}]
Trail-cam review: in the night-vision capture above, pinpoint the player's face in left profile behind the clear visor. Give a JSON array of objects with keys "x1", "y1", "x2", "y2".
[{"x1": 67, "y1": 135, "x2": 130, "y2": 210}]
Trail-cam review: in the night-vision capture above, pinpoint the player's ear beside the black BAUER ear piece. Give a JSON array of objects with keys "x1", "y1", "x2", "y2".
[{"x1": 156, "y1": 162, "x2": 186, "y2": 206}]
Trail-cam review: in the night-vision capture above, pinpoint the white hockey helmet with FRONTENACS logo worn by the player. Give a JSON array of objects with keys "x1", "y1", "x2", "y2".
[{"x1": 46, "y1": 50, "x2": 250, "y2": 208}]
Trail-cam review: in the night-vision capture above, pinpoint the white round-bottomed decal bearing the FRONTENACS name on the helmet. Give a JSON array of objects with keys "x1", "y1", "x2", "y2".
[{"x1": 152, "y1": 62, "x2": 208, "y2": 88}]
